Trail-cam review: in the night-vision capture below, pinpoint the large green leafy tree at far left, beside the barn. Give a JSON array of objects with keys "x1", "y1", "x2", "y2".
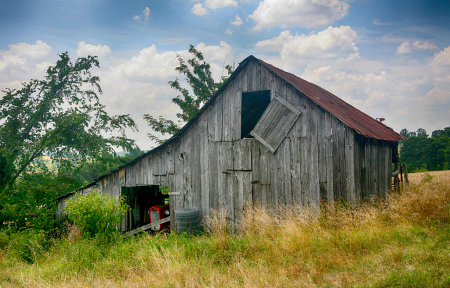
[{"x1": 0, "y1": 53, "x2": 137, "y2": 193}]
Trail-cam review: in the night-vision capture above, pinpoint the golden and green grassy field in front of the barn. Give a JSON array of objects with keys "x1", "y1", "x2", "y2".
[{"x1": 0, "y1": 172, "x2": 450, "y2": 287}]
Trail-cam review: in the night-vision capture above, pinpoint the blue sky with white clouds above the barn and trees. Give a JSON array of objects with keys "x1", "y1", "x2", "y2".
[{"x1": 0, "y1": 0, "x2": 450, "y2": 149}]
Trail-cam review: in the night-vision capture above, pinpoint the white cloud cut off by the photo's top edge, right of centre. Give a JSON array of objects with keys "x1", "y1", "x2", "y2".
[{"x1": 249, "y1": 0, "x2": 350, "y2": 30}]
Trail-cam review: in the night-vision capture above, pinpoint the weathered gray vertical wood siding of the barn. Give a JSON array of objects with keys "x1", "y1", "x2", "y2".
[{"x1": 58, "y1": 58, "x2": 396, "y2": 227}]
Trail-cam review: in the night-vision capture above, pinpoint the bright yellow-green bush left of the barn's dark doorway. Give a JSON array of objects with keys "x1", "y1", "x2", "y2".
[{"x1": 66, "y1": 190, "x2": 128, "y2": 241}]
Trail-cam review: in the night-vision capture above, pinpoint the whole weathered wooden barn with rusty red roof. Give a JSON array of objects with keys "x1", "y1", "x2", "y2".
[{"x1": 58, "y1": 56, "x2": 403, "y2": 230}]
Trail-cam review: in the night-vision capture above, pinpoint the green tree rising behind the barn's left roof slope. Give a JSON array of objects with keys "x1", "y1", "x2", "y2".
[{"x1": 144, "y1": 45, "x2": 233, "y2": 144}]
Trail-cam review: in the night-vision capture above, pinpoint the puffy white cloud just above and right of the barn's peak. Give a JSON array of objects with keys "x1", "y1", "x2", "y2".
[{"x1": 255, "y1": 26, "x2": 359, "y2": 61}]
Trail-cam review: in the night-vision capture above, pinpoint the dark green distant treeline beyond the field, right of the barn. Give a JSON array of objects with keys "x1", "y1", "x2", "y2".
[{"x1": 400, "y1": 127, "x2": 450, "y2": 172}]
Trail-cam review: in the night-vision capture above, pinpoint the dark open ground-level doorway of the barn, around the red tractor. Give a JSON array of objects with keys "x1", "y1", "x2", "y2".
[{"x1": 122, "y1": 185, "x2": 169, "y2": 232}]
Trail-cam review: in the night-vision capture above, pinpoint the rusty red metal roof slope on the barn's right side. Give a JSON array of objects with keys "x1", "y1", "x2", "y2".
[{"x1": 256, "y1": 56, "x2": 405, "y2": 141}]
